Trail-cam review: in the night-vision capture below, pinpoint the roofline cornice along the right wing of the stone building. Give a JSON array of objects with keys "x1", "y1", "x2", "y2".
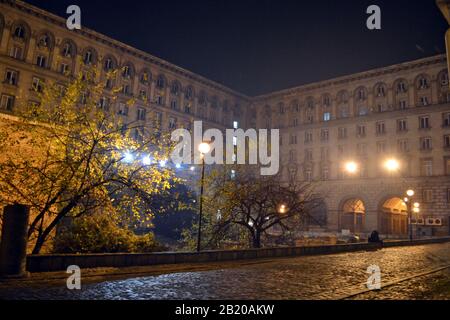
[{"x1": 253, "y1": 54, "x2": 447, "y2": 101}]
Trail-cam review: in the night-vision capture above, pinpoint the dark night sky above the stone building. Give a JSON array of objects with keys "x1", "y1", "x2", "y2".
[{"x1": 26, "y1": 0, "x2": 447, "y2": 96}]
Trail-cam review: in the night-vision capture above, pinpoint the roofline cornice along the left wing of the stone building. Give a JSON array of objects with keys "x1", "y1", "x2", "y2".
[{"x1": 0, "y1": 0, "x2": 251, "y2": 100}]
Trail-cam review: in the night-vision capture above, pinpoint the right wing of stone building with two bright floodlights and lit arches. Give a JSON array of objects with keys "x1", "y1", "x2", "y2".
[{"x1": 253, "y1": 55, "x2": 450, "y2": 237}]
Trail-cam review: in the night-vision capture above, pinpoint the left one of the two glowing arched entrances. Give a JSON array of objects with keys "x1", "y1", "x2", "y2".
[{"x1": 340, "y1": 198, "x2": 366, "y2": 233}]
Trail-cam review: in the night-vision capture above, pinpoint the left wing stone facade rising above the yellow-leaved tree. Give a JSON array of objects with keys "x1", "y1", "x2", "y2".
[{"x1": 0, "y1": 0, "x2": 248, "y2": 139}]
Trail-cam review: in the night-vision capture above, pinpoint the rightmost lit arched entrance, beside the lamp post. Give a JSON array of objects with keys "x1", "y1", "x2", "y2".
[{"x1": 380, "y1": 197, "x2": 408, "y2": 236}]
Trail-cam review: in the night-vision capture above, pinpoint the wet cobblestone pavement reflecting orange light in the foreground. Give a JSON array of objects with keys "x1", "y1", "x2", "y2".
[{"x1": 0, "y1": 243, "x2": 450, "y2": 300}]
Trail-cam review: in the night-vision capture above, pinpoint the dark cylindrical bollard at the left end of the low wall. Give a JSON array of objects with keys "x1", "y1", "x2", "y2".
[{"x1": 0, "y1": 204, "x2": 30, "y2": 278}]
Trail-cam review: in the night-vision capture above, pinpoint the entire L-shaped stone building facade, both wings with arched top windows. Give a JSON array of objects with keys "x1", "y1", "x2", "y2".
[{"x1": 0, "y1": 0, "x2": 450, "y2": 237}]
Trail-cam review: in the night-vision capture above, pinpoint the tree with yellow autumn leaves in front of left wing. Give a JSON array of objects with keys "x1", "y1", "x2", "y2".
[{"x1": 0, "y1": 66, "x2": 176, "y2": 254}]
